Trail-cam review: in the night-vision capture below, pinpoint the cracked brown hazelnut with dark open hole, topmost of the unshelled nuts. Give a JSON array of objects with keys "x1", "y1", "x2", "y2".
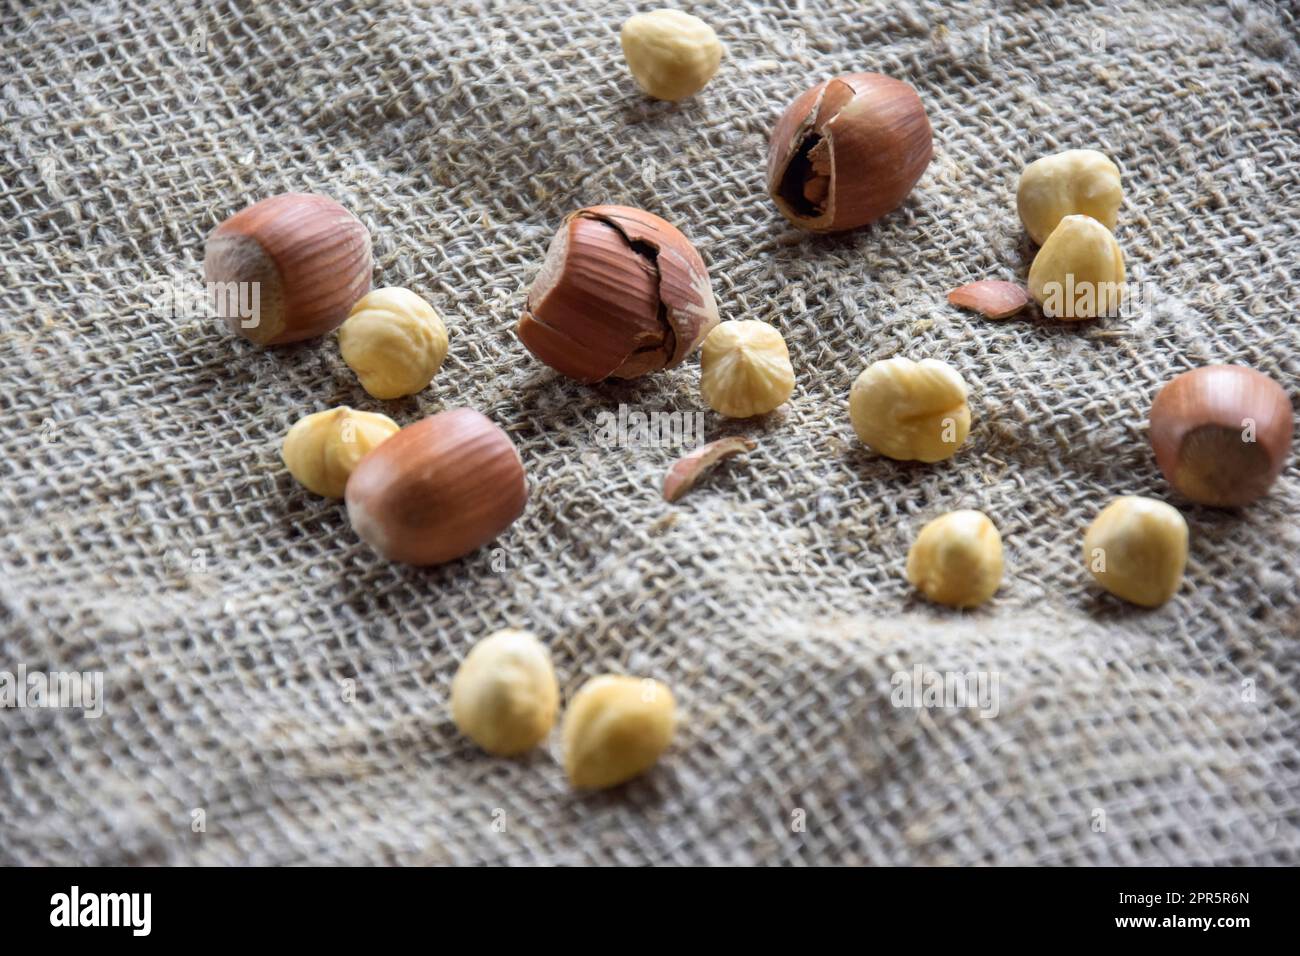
[{"x1": 767, "y1": 73, "x2": 935, "y2": 233}]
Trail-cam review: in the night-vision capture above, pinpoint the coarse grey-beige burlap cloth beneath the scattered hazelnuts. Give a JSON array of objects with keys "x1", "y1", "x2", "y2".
[{"x1": 0, "y1": 0, "x2": 1300, "y2": 865}]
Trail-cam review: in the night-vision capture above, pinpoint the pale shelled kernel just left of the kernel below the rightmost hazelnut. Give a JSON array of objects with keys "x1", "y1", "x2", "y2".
[{"x1": 907, "y1": 510, "x2": 1002, "y2": 607}]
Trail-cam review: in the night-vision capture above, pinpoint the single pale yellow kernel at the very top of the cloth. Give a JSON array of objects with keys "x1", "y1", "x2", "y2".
[{"x1": 619, "y1": 10, "x2": 723, "y2": 100}]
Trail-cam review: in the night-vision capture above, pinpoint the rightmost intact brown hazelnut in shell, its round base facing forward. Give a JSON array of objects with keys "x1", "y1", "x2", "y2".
[{"x1": 1151, "y1": 365, "x2": 1294, "y2": 507}]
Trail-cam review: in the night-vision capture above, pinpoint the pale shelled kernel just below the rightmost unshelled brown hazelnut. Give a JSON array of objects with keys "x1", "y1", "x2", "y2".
[{"x1": 1083, "y1": 496, "x2": 1187, "y2": 607}]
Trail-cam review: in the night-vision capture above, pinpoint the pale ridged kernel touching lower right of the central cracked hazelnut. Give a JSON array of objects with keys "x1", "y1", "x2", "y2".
[{"x1": 699, "y1": 320, "x2": 794, "y2": 419}]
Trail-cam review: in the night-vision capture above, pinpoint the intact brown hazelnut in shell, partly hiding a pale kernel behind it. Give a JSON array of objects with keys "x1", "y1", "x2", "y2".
[{"x1": 345, "y1": 408, "x2": 528, "y2": 564}]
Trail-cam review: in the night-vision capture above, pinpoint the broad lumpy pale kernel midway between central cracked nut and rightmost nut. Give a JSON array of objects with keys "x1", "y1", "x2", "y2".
[{"x1": 849, "y1": 358, "x2": 971, "y2": 462}]
